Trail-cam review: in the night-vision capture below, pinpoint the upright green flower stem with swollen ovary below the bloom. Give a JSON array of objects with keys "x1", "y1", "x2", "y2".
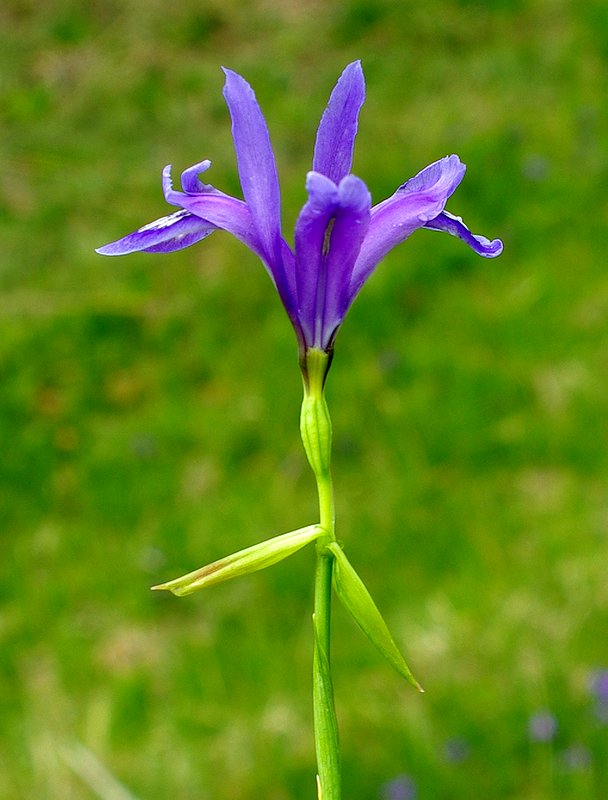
[{"x1": 300, "y1": 349, "x2": 341, "y2": 800}]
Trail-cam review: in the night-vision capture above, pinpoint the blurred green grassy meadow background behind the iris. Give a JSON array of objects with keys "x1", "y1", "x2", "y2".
[{"x1": 0, "y1": 0, "x2": 608, "y2": 800}]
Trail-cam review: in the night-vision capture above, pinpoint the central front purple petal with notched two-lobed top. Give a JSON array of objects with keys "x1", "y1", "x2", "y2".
[{"x1": 295, "y1": 172, "x2": 371, "y2": 350}]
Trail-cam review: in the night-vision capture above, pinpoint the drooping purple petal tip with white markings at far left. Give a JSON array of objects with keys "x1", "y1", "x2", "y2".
[{"x1": 96, "y1": 209, "x2": 216, "y2": 256}]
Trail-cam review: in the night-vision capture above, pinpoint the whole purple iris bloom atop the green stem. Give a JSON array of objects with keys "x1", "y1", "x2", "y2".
[{"x1": 97, "y1": 61, "x2": 502, "y2": 355}]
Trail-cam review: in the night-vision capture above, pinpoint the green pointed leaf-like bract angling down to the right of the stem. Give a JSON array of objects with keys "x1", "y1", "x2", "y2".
[{"x1": 327, "y1": 542, "x2": 424, "y2": 692}]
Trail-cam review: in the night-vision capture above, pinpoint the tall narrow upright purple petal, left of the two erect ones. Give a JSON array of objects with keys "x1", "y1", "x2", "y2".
[{"x1": 224, "y1": 69, "x2": 281, "y2": 264}]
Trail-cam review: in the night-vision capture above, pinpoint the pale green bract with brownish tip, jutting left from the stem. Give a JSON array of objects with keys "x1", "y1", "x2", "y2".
[{"x1": 152, "y1": 525, "x2": 324, "y2": 597}]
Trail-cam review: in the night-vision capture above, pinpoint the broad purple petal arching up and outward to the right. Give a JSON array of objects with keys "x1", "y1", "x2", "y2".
[{"x1": 350, "y1": 155, "x2": 466, "y2": 298}]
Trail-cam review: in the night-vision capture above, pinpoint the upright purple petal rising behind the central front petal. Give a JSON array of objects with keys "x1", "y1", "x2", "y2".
[{"x1": 312, "y1": 61, "x2": 365, "y2": 184}]
